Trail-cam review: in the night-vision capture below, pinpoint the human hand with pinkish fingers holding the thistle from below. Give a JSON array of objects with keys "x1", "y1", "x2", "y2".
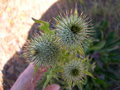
[{"x1": 10, "y1": 64, "x2": 60, "y2": 90}]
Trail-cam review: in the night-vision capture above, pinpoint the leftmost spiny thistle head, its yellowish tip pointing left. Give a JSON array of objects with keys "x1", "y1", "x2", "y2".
[{"x1": 24, "y1": 35, "x2": 60, "y2": 66}]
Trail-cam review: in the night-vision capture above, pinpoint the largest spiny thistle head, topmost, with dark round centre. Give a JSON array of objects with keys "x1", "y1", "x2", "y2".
[{"x1": 56, "y1": 13, "x2": 93, "y2": 48}]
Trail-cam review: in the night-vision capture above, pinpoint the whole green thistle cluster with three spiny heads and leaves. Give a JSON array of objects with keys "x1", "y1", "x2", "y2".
[{"x1": 24, "y1": 10, "x2": 95, "y2": 90}]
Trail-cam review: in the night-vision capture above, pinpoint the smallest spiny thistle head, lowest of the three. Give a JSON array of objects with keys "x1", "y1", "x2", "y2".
[{"x1": 63, "y1": 60, "x2": 92, "y2": 84}]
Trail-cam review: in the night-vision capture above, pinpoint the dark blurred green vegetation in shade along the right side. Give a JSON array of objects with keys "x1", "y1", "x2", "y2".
[{"x1": 72, "y1": 0, "x2": 120, "y2": 90}]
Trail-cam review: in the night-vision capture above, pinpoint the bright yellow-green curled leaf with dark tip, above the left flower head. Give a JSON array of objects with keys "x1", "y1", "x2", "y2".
[{"x1": 32, "y1": 18, "x2": 53, "y2": 34}]
